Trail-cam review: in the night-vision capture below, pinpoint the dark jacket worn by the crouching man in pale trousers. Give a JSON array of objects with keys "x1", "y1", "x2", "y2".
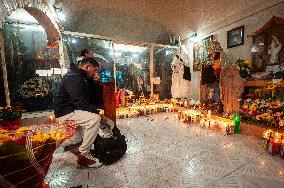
[{"x1": 54, "y1": 66, "x2": 99, "y2": 117}]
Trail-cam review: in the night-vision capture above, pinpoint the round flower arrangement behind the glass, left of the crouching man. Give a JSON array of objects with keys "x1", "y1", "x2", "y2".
[{"x1": 18, "y1": 77, "x2": 50, "y2": 99}]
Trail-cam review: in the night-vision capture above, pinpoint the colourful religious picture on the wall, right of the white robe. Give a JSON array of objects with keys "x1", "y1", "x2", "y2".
[{"x1": 193, "y1": 35, "x2": 213, "y2": 71}]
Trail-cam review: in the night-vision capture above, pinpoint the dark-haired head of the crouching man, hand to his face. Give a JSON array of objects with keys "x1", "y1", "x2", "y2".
[{"x1": 78, "y1": 58, "x2": 100, "y2": 80}]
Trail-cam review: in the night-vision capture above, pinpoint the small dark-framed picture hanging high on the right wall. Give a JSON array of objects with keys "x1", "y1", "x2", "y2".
[{"x1": 227, "y1": 26, "x2": 244, "y2": 48}]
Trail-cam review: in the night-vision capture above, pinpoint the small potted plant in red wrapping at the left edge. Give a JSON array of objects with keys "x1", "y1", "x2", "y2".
[{"x1": 0, "y1": 107, "x2": 22, "y2": 129}]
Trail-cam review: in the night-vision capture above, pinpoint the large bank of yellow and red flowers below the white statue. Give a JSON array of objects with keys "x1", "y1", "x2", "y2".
[{"x1": 241, "y1": 83, "x2": 284, "y2": 129}]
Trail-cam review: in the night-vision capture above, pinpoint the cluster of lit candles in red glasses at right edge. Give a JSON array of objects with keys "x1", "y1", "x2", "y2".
[{"x1": 263, "y1": 129, "x2": 284, "y2": 158}]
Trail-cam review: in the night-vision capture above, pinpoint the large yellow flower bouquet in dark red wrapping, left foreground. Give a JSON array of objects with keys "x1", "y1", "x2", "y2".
[{"x1": 0, "y1": 121, "x2": 75, "y2": 187}]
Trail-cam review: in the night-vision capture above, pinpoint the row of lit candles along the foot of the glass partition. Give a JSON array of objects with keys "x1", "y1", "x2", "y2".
[{"x1": 116, "y1": 104, "x2": 178, "y2": 119}]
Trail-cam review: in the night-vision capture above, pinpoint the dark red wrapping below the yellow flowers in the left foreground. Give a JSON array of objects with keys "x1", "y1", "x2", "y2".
[{"x1": 0, "y1": 141, "x2": 56, "y2": 188}]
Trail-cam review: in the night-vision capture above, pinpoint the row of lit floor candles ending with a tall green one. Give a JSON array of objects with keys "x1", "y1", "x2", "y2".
[{"x1": 178, "y1": 110, "x2": 240, "y2": 135}]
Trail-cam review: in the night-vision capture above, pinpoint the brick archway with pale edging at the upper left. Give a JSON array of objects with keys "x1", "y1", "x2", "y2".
[{"x1": 0, "y1": 0, "x2": 65, "y2": 106}]
